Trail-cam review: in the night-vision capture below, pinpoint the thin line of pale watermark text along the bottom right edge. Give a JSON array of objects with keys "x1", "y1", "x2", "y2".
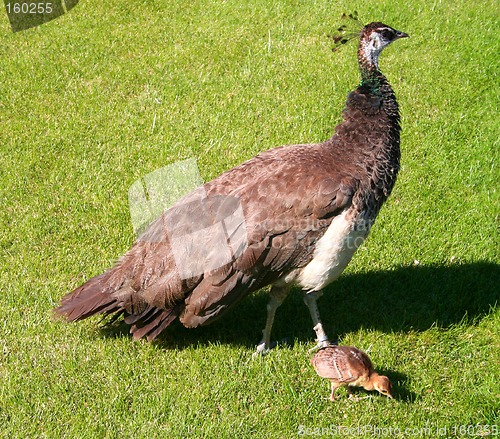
[{"x1": 297, "y1": 424, "x2": 499, "y2": 437}]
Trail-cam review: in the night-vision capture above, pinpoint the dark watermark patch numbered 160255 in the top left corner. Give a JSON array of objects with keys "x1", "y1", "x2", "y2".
[{"x1": 4, "y1": 0, "x2": 79, "y2": 32}]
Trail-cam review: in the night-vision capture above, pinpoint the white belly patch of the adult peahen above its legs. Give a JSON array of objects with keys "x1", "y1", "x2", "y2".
[{"x1": 296, "y1": 210, "x2": 369, "y2": 291}]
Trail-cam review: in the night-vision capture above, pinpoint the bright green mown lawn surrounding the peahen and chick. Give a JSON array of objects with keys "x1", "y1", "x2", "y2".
[{"x1": 0, "y1": 0, "x2": 500, "y2": 438}]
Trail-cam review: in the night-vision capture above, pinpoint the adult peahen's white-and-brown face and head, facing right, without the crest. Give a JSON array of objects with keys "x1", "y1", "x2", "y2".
[{"x1": 358, "y1": 22, "x2": 408, "y2": 72}]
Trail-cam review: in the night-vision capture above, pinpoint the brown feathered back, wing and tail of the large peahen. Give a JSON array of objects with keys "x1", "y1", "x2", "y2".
[{"x1": 56, "y1": 144, "x2": 358, "y2": 339}]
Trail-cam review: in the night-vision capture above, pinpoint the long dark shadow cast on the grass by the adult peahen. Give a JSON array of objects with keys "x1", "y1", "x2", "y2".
[{"x1": 102, "y1": 262, "x2": 500, "y2": 349}]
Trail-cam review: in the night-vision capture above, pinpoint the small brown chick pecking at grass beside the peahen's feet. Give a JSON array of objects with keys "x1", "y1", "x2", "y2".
[{"x1": 311, "y1": 346, "x2": 392, "y2": 401}]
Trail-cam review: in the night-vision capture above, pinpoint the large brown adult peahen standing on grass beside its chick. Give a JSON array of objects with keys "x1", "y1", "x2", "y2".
[{"x1": 55, "y1": 22, "x2": 408, "y2": 353}]
